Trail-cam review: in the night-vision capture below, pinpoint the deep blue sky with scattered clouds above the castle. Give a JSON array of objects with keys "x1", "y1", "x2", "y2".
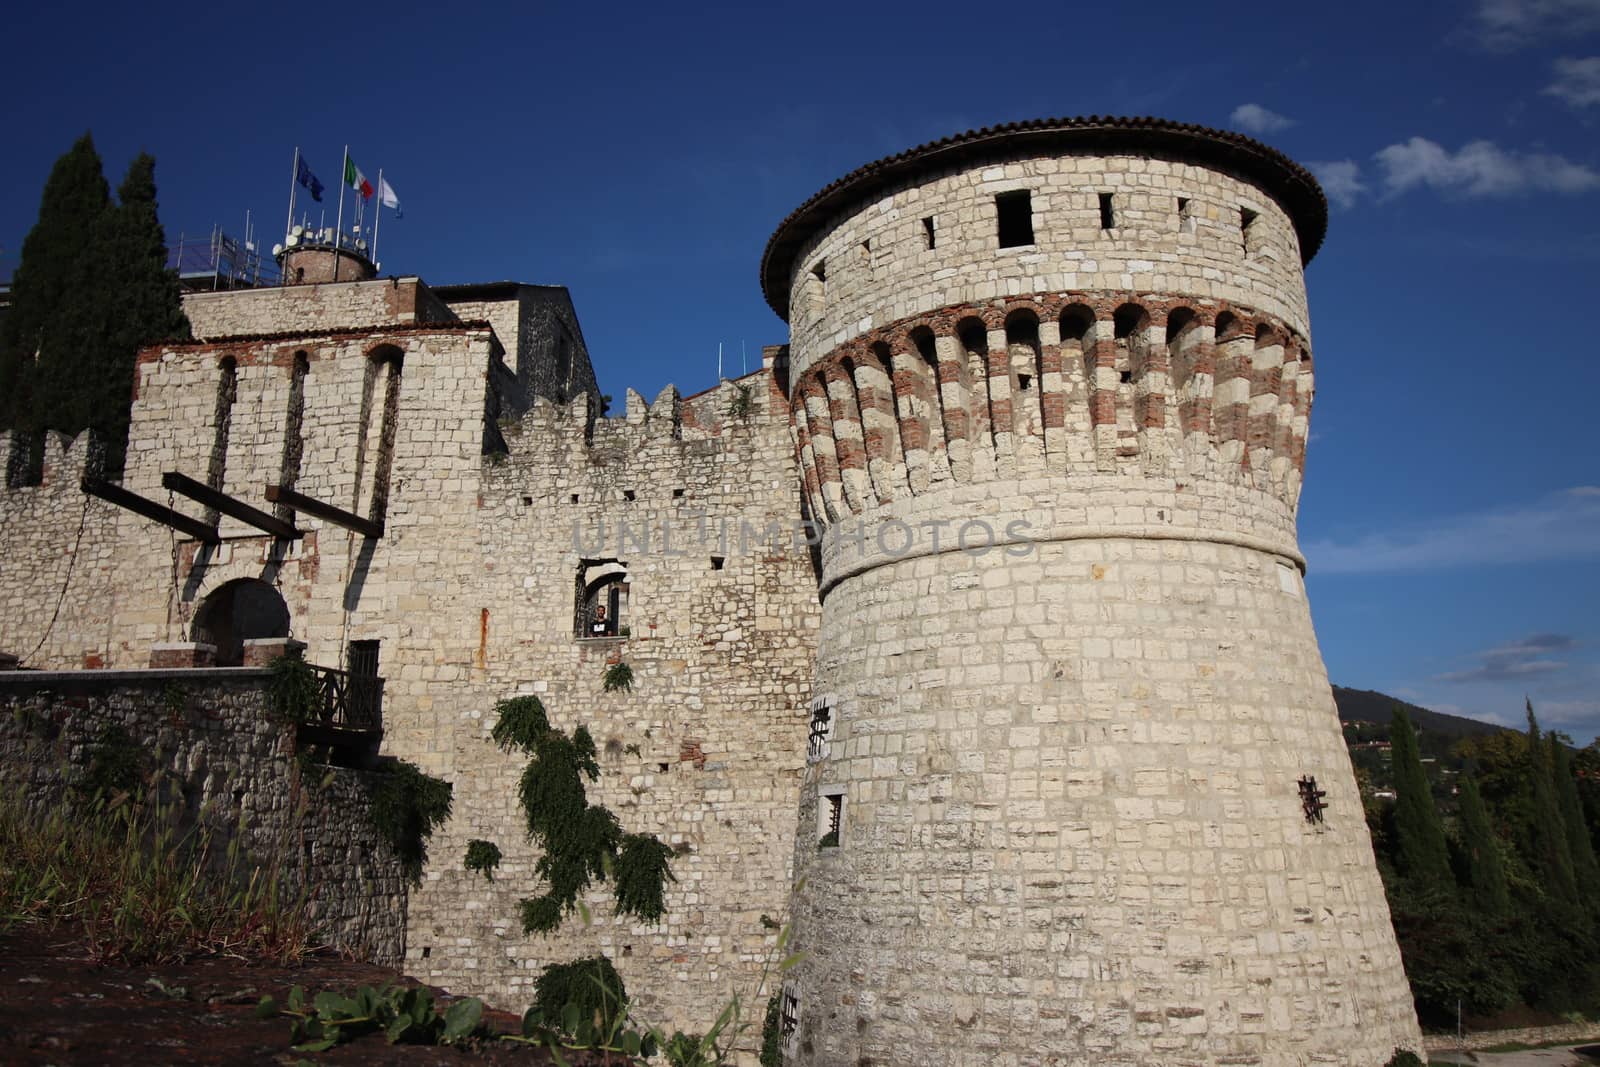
[{"x1": 0, "y1": 0, "x2": 1600, "y2": 742}]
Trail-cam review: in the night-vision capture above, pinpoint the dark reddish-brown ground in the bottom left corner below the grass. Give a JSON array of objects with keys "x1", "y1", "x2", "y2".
[{"x1": 0, "y1": 931, "x2": 566, "y2": 1067}]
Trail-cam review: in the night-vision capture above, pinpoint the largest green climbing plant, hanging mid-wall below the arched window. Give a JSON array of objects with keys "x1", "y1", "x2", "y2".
[{"x1": 490, "y1": 696, "x2": 674, "y2": 934}]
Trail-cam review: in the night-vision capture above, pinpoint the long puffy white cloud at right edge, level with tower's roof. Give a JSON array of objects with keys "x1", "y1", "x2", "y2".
[{"x1": 1373, "y1": 138, "x2": 1600, "y2": 197}]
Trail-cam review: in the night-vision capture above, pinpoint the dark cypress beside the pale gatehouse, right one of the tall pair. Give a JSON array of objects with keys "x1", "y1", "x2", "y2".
[{"x1": 86, "y1": 152, "x2": 189, "y2": 474}]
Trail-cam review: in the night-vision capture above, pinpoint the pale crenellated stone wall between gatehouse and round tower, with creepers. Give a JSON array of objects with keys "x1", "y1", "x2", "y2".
[{"x1": 406, "y1": 371, "x2": 818, "y2": 1040}]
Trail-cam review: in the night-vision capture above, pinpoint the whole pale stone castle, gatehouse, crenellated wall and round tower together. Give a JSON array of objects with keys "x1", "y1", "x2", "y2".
[{"x1": 0, "y1": 118, "x2": 1419, "y2": 1067}]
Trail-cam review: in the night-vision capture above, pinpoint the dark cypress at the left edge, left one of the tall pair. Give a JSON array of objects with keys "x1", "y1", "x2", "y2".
[{"x1": 0, "y1": 133, "x2": 110, "y2": 447}]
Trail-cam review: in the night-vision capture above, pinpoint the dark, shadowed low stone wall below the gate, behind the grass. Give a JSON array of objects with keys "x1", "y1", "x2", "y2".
[{"x1": 0, "y1": 669, "x2": 406, "y2": 965}]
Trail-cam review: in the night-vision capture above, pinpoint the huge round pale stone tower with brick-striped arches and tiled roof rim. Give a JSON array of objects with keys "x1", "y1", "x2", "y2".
[{"x1": 762, "y1": 118, "x2": 1421, "y2": 1067}]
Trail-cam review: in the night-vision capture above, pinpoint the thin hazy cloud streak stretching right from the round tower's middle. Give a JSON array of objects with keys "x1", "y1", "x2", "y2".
[{"x1": 1306, "y1": 486, "x2": 1600, "y2": 574}]
